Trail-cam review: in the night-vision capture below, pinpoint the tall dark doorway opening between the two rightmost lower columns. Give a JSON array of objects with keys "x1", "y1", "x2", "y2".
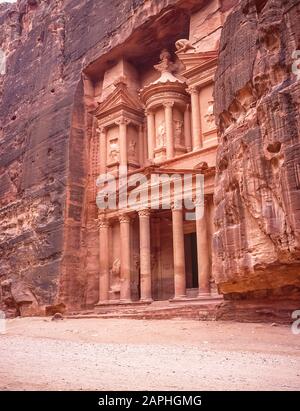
[{"x1": 184, "y1": 233, "x2": 198, "y2": 288}]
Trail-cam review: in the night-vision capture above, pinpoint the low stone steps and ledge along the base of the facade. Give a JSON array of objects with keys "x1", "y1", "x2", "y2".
[{"x1": 64, "y1": 296, "x2": 299, "y2": 325}]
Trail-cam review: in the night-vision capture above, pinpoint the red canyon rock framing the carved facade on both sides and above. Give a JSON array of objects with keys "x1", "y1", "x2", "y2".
[{"x1": 0, "y1": 0, "x2": 300, "y2": 315}]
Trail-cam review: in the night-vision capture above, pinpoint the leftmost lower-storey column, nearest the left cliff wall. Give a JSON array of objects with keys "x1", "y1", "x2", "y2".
[{"x1": 98, "y1": 217, "x2": 109, "y2": 304}]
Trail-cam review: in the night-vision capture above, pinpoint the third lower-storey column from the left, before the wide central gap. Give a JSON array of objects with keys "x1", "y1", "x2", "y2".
[{"x1": 138, "y1": 210, "x2": 152, "y2": 302}]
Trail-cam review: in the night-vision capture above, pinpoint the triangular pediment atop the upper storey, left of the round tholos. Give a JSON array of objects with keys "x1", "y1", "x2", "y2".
[{"x1": 95, "y1": 82, "x2": 143, "y2": 117}]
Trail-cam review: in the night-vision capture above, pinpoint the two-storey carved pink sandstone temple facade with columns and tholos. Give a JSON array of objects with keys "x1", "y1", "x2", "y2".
[{"x1": 85, "y1": 2, "x2": 232, "y2": 305}]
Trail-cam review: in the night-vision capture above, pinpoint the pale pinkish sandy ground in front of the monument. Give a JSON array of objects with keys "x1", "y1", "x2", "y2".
[{"x1": 0, "y1": 318, "x2": 300, "y2": 391}]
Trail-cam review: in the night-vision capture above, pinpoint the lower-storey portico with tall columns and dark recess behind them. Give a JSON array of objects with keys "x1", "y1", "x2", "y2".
[{"x1": 97, "y1": 195, "x2": 213, "y2": 305}]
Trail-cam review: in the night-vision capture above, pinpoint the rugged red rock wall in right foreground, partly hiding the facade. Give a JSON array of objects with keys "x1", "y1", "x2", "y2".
[{"x1": 213, "y1": 0, "x2": 300, "y2": 298}]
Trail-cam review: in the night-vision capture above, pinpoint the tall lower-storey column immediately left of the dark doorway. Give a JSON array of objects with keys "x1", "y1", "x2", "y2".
[{"x1": 172, "y1": 207, "x2": 186, "y2": 299}]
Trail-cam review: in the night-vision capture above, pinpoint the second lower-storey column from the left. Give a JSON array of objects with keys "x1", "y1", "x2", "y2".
[{"x1": 119, "y1": 214, "x2": 131, "y2": 302}]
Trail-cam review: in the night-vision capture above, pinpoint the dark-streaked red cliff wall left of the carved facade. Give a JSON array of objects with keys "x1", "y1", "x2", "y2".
[{"x1": 0, "y1": 0, "x2": 202, "y2": 312}]
